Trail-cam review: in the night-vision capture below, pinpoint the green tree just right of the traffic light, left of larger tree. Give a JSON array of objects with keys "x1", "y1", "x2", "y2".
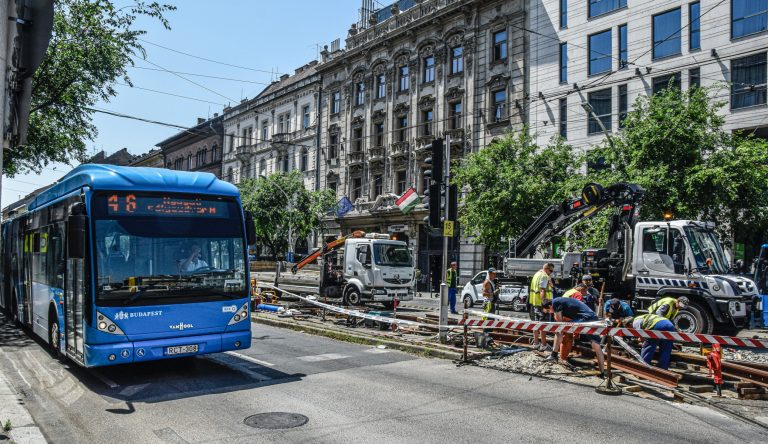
[{"x1": 452, "y1": 129, "x2": 579, "y2": 251}]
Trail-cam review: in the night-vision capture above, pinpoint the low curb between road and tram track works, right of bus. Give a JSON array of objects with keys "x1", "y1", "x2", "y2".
[{"x1": 251, "y1": 316, "x2": 462, "y2": 360}]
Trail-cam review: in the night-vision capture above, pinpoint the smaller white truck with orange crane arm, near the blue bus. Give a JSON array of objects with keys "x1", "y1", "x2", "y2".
[{"x1": 291, "y1": 231, "x2": 414, "y2": 308}]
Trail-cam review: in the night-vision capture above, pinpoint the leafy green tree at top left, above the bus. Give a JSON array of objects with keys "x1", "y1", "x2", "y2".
[{"x1": 3, "y1": 0, "x2": 176, "y2": 177}]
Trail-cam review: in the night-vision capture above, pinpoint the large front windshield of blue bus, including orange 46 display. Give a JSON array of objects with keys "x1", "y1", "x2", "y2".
[{"x1": 92, "y1": 193, "x2": 247, "y2": 306}]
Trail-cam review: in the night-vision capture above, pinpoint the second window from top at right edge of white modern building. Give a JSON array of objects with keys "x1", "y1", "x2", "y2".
[{"x1": 731, "y1": 53, "x2": 768, "y2": 109}]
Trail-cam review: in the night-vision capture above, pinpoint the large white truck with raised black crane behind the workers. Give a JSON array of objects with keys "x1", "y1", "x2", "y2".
[{"x1": 504, "y1": 183, "x2": 757, "y2": 334}]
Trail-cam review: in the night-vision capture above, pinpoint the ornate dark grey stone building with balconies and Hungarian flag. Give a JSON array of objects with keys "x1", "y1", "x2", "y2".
[{"x1": 317, "y1": 0, "x2": 527, "y2": 282}]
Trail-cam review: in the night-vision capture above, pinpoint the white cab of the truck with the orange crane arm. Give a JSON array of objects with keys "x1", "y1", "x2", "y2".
[{"x1": 343, "y1": 233, "x2": 414, "y2": 305}]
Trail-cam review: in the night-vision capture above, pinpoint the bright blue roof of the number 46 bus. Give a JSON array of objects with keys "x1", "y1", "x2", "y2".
[{"x1": 27, "y1": 164, "x2": 239, "y2": 210}]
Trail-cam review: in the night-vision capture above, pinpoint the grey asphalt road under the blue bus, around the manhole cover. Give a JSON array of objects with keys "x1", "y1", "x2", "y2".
[{"x1": 0, "y1": 318, "x2": 768, "y2": 444}]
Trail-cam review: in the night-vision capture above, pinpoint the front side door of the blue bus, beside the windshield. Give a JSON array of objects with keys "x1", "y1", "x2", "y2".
[{"x1": 64, "y1": 251, "x2": 85, "y2": 363}]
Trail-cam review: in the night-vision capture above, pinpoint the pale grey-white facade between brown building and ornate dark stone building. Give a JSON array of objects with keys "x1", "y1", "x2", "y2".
[{"x1": 223, "y1": 61, "x2": 320, "y2": 190}]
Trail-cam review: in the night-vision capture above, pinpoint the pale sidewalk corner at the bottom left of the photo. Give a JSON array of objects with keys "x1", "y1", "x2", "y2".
[{"x1": 0, "y1": 360, "x2": 47, "y2": 444}]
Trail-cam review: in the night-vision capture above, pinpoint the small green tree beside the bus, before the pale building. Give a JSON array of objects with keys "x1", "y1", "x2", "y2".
[{"x1": 238, "y1": 171, "x2": 336, "y2": 255}]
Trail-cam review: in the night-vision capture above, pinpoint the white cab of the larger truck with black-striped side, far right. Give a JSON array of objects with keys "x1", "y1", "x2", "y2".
[{"x1": 625, "y1": 220, "x2": 757, "y2": 333}]
